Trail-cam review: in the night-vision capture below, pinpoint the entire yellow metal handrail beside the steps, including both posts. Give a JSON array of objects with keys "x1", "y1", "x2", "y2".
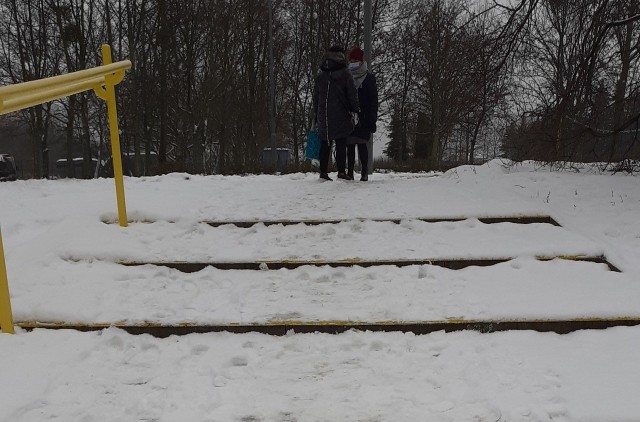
[{"x1": 0, "y1": 44, "x2": 131, "y2": 333}]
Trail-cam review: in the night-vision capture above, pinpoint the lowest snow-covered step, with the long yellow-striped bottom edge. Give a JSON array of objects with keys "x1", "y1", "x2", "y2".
[{"x1": 12, "y1": 258, "x2": 640, "y2": 331}]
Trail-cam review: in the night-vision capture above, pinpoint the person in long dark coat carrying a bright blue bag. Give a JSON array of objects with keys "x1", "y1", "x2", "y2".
[{"x1": 313, "y1": 46, "x2": 360, "y2": 180}]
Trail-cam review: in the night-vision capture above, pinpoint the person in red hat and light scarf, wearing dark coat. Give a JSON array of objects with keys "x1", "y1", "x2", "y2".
[{"x1": 346, "y1": 47, "x2": 378, "y2": 182}]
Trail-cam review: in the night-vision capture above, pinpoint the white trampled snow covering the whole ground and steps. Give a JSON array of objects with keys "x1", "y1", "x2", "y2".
[{"x1": 0, "y1": 160, "x2": 640, "y2": 422}]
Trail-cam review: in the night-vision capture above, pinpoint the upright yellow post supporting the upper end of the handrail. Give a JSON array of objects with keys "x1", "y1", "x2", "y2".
[{"x1": 102, "y1": 44, "x2": 128, "y2": 227}]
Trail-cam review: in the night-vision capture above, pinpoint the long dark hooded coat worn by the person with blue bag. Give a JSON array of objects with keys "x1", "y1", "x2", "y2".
[{"x1": 313, "y1": 51, "x2": 360, "y2": 142}]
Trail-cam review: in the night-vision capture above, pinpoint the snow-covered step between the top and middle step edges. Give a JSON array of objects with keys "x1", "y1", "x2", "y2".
[{"x1": 63, "y1": 219, "x2": 605, "y2": 262}]
